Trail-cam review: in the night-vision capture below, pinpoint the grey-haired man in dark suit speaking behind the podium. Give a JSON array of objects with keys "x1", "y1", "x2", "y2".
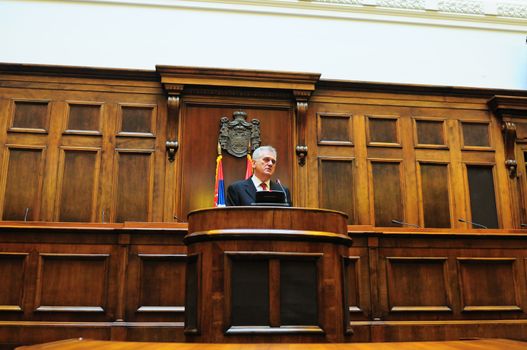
[{"x1": 227, "y1": 146, "x2": 292, "y2": 206}]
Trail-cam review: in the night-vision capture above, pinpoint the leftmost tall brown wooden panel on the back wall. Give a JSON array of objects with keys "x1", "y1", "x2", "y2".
[{"x1": 2, "y1": 145, "x2": 45, "y2": 221}]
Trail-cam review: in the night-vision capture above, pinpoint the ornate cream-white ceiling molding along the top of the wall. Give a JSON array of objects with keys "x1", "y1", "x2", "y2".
[{"x1": 55, "y1": 0, "x2": 527, "y2": 33}]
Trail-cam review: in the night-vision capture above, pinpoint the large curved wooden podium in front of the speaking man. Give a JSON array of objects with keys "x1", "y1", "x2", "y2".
[{"x1": 184, "y1": 207, "x2": 352, "y2": 343}]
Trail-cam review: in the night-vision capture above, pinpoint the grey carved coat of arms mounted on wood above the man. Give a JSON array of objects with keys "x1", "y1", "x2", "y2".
[{"x1": 218, "y1": 111, "x2": 260, "y2": 158}]
